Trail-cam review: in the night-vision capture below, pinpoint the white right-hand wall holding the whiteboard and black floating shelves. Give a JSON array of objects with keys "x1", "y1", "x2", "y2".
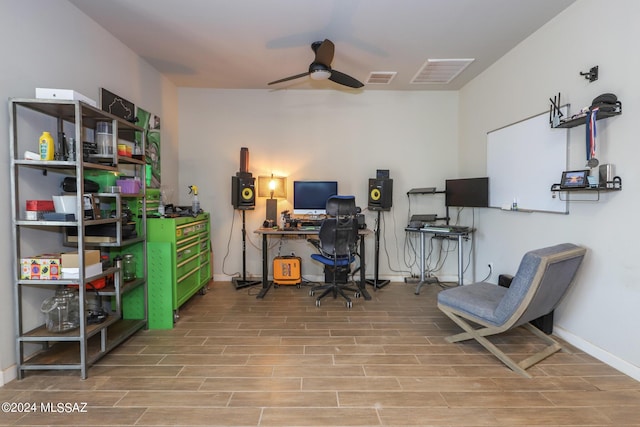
[{"x1": 460, "y1": 0, "x2": 640, "y2": 379}]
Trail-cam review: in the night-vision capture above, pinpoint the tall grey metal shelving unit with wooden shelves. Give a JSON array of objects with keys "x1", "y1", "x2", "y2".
[{"x1": 9, "y1": 98, "x2": 148, "y2": 379}]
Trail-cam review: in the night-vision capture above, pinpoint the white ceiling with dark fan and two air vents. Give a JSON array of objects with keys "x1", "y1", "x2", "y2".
[{"x1": 69, "y1": 0, "x2": 575, "y2": 90}]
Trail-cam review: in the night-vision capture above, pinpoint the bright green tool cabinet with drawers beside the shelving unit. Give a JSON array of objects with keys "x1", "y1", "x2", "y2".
[{"x1": 147, "y1": 212, "x2": 211, "y2": 329}]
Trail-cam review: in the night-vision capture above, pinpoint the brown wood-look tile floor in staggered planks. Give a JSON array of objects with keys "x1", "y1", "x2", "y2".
[{"x1": 0, "y1": 282, "x2": 640, "y2": 427}]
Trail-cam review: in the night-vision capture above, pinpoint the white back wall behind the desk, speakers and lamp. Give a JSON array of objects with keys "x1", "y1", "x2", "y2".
[{"x1": 174, "y1": 88, "x2": 458, "y2": 280}]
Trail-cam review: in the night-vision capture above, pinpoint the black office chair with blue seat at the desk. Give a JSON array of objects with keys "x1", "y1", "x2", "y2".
[{"x1": 309, "y1": 196, "x2": 360, "y2": 308}]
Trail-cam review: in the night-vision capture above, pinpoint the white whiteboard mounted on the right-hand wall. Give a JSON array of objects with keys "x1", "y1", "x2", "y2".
[{"x1": 487, "y1": 107, "x2": 569, "y2": 213}]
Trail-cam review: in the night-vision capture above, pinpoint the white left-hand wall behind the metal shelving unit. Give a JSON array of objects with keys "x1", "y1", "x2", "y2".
[{"x1": 0, "y1": 0, "x2": 177, "y2": 385}]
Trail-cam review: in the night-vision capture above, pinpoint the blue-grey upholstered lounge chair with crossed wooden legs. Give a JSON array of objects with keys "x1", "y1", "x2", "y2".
[{"x1": 438, "y1": 243, "x2": 586, "y2": 378}]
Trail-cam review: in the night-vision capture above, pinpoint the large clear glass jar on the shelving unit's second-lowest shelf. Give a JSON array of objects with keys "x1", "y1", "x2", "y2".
[{"x1": 40, "y1": 288, "x2": 80, "y2": 332}]
